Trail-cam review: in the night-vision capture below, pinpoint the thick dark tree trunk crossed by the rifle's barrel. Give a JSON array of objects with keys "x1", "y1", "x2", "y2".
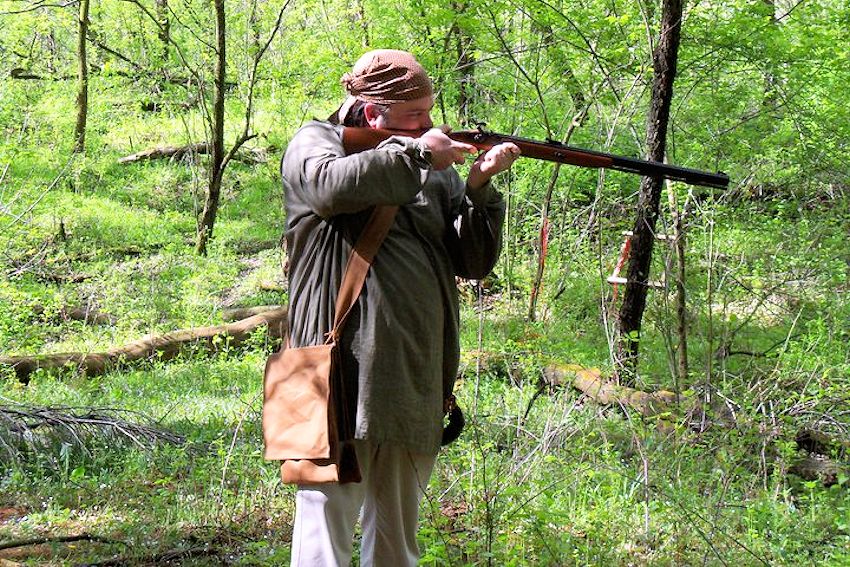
[{"x1": 617, "y1": 0, "x2": 682, "y2": 384}]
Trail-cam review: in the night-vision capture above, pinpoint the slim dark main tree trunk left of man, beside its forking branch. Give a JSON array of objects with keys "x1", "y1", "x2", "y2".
[{"x1": 196, "y1": 0, "x2": 226, "y2": 256}]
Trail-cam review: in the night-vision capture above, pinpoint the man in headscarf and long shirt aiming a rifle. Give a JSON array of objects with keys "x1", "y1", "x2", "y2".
[{"x1": 282, "y1": 50, "x2": 519, "y2": 567}]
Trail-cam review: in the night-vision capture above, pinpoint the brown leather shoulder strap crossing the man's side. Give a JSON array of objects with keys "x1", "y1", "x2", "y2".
[{"x1": 328, "y1": 205, "x2": 398, "y2": 342}]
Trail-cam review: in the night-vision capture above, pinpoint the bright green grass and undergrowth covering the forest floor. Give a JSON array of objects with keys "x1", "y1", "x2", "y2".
[{"x1": 0, "y1": 69, "x2": 850, "y2": 566}]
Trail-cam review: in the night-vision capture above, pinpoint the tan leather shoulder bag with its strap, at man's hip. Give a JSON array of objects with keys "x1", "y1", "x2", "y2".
[{"x1": 263, "y1": 206, "x2": 398, "y2": 484}]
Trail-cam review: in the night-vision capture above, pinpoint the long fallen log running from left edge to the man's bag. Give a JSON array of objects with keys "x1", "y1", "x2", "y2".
[{"x1": 0, "y1": 308, "x2": 286, "y2": 383}]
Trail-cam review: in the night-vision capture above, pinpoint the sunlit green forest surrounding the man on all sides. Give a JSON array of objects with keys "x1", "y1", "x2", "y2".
[{"x1": 0, "y1": 0, "x2": 850, "y2": 566}]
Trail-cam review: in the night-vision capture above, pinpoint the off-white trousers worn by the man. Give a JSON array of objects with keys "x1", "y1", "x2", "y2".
[{"x1": 292, "y1": 441, "x2": 436, "y2": 567}]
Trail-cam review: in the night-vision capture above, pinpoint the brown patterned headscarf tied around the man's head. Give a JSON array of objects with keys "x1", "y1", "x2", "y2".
[{"x1": 338, "y1": 49, "x2": 434, "y2": 122}]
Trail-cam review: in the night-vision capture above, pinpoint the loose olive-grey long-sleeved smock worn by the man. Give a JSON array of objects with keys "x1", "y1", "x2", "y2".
[{"x1": 281, "y1": 122, "x2": 505, "y2": 453}]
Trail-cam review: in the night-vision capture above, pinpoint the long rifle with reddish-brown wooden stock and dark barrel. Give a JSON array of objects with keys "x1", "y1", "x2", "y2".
[{"x1": 342, "y1": 127, "x2": 729, "y2": 189}]
